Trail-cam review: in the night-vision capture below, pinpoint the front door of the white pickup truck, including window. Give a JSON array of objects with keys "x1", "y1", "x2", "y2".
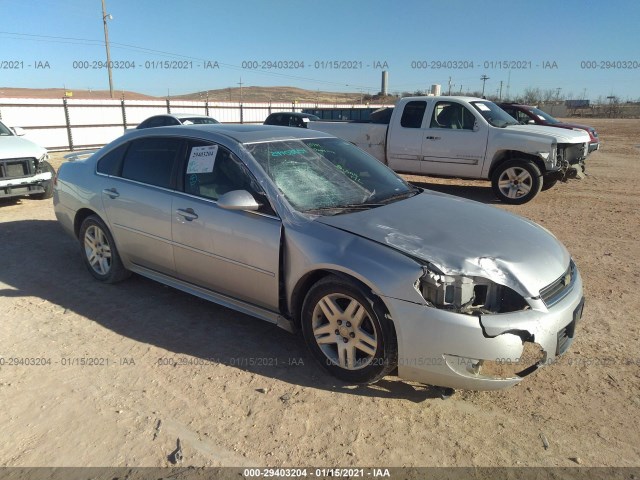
[{"x1": 422, "y1": 100, "x2": 489, "y2": 178}]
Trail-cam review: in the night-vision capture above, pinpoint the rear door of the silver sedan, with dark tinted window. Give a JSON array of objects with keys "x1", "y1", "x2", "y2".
[{"x1": 98, "y1": 137, "x2": 185, "y2": 275}]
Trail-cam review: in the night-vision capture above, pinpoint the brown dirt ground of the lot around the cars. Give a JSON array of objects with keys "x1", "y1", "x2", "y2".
[{"x1": 0, "y1": 119, "x2": 640, "y2": 466}]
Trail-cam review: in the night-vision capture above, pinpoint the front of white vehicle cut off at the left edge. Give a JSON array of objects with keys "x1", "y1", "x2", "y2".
[{"x1": 0, "y1": 122, "x2": 56, "y2": 199}]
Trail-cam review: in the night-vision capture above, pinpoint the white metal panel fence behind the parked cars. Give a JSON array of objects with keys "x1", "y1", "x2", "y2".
[{"x1": 0, "y1": 98, "x2": 382, "y2": 150}]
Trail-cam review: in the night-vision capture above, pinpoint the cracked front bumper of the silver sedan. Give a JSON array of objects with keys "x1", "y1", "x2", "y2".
[{"x1": 385, "y1": 270, "x2": 584, "y2": 390}]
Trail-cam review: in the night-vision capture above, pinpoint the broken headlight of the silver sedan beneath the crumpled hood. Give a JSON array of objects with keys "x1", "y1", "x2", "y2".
[{"x1": 420, "y1": 270, "x2": 529, "y2": 315}]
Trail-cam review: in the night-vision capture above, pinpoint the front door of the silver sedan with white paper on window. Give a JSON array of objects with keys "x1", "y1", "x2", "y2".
[{"x1": 172, "y1": 141, "x2": 281, "y2": 311}]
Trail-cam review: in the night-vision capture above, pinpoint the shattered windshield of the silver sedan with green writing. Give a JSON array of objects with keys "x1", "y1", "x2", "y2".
[{"x1": 245, "y1": 138, "x2": 419, "y2": 215}]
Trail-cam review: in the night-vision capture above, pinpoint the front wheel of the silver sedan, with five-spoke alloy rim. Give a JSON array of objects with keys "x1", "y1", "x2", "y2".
[{"x1": 301, "y1": 276, "x2": 398, "y2": 384}]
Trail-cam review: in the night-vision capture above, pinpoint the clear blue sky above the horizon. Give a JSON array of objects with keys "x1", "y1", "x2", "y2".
[{"x1": 0, "y1": 0, "x2": 640, "y2": 100}]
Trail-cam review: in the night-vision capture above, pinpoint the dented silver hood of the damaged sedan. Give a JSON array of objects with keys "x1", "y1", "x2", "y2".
[{"x1": 317, "y1": 192, "x2": 570, "y2": 297}]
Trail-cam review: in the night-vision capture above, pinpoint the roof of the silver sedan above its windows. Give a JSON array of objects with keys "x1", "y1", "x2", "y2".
[{"x1": 126, "y1": 123, "x2": 333, "y2": 143}]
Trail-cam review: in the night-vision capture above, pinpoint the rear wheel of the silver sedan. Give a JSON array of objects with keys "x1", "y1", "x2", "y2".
[{"x1": 78, "y1": 215, "x2": 131, "y2": 283}]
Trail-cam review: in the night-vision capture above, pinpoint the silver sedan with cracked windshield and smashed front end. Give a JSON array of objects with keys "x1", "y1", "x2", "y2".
[{"x1": 54, "y1": 125, "x2": 584, "y2": 389}]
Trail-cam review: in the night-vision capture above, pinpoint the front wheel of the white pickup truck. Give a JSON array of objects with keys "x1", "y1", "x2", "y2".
[{"x1": 491, "y1": 159, "x2": 542, "y2": 205}]
